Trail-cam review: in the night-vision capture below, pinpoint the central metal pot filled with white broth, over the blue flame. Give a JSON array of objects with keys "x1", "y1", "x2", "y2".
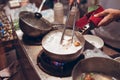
[{"x1": 42, "y1": 30, "x2": 85, "y2": 60}]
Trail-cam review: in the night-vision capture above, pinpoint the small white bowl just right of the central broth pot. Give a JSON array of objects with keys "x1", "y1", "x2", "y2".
[{"x1": 84, "y1": 35, "x2": 104, "y2": 49}]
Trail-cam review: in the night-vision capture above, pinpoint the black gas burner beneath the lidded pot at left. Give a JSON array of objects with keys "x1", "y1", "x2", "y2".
[{"x1": 22, "y1": 34, "x2": 43, "y2": 45}]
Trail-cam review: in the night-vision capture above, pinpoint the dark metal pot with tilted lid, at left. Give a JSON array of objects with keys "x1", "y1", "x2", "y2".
[{"x1": 19, "y1": 11, "x2": 52, "y2": 37}]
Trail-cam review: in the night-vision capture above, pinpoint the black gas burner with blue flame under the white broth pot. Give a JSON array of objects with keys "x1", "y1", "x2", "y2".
[{"x1": 37, "y1": 52, "x2": 84, "y2": 77}]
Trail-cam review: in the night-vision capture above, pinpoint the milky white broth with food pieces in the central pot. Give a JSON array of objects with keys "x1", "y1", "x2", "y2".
[{"x1": 42, "y1": 30, "x2": 82, "y2": 54}]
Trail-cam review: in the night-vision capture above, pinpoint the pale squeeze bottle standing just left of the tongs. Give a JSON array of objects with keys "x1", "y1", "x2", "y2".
[{"x1": 54, "y1": 1, "x2": 64, "y2": 24}]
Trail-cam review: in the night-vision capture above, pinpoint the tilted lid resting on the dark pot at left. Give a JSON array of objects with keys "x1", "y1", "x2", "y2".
[{"x1": 19, "y1": 11, "x2": 52, "y2": 30}]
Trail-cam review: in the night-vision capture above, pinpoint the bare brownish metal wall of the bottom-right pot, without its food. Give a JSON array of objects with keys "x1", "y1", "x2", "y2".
[{"x1": 72, "y1": 57, "x2": 120, "y2": 80}]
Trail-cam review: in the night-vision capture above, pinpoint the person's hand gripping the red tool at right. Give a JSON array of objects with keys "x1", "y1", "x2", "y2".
[{"x1": 94, "y1": 9, "x2": 120, "y2": 26}]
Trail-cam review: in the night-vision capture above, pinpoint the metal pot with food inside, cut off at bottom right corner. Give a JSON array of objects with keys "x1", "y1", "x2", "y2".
[{"x1": 72, "y1": 57, "x2": 120, "y2": 80}]
